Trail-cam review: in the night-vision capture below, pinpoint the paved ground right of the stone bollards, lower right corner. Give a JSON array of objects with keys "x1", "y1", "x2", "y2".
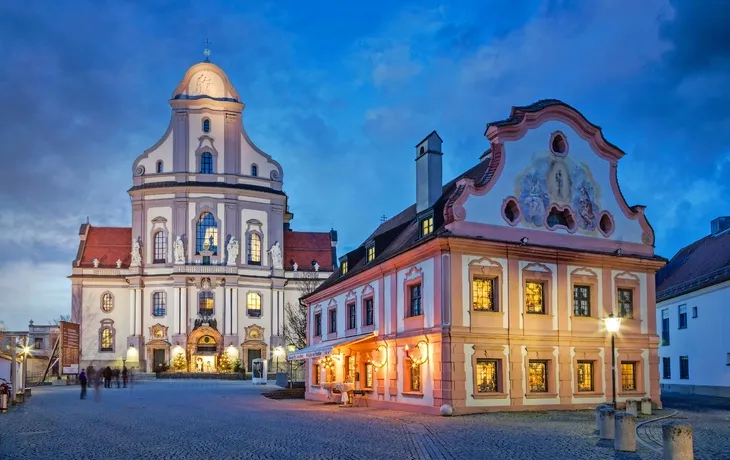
[{"x1": 637, "y1": 395, "x2": 730, "y2": 460}]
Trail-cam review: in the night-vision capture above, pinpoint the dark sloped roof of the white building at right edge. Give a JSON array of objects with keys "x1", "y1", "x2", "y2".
[{"x1": 656, "y1": 231, "x2": 730, "y2": 301}]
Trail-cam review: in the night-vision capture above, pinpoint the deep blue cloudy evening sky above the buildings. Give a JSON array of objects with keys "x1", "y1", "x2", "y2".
[{"x1": 0, "y1": 0, "x2": 730, "y2": 329}]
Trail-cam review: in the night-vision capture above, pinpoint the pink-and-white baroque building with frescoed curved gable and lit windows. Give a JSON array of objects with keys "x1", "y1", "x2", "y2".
[{"x1": 288, "y1": 100, "x2": 666, "y2": 413}]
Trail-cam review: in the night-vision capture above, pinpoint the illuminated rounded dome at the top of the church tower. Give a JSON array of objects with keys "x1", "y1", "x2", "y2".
[{"x1": 171, "y1": 62, "x2": 241, "y2": 102}]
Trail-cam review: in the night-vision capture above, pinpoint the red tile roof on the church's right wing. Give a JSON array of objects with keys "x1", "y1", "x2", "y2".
[{"x1": 284, "y1": 231, "x2": 333, "y2": 272}]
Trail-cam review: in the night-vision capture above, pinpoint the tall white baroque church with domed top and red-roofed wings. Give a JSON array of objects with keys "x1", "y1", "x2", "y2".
[{"x1": 69, "y1": 61, "x2": 337, "y2": 372}]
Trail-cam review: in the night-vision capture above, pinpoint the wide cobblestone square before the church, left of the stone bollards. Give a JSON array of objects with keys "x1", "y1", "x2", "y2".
[{"x1": 0, "y1": 381, "x2": 660, "y2": 460}]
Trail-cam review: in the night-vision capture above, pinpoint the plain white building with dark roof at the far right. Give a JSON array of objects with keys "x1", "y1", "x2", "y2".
[{"x1": 656, "y1": 217, "x2": 730, "y2": 397}]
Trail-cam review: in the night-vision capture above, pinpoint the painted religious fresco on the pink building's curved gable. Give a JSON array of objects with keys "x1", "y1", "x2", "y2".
[{"x1": 515, "y1": 151, "x2": 600, "y2": 233}]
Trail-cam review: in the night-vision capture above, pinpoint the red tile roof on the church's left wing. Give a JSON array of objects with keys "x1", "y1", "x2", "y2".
[{"x1": 76, "y1": 224, "x2": 132, "y2": 268}]
